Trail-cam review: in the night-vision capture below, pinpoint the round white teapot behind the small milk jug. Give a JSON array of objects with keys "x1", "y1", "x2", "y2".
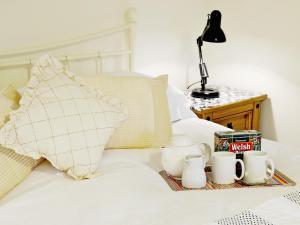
[{"x1": 162, "y1": 135, "x2": 211, "y2": 178}]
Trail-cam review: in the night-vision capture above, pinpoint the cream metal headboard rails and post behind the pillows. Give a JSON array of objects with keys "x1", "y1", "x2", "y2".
[{"x1": 0, "y1": 8, "x2": 136, "y2": 72}]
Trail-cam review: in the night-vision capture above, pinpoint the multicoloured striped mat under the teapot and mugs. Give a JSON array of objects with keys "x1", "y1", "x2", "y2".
[{"x1": 159, "y1": 167, "x2": 296, "y2": 191}]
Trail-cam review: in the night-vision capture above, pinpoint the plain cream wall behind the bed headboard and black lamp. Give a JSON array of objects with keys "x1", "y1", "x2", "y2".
[{"x1": 0, "y1": 0, "x2": 300, "y2": 146}]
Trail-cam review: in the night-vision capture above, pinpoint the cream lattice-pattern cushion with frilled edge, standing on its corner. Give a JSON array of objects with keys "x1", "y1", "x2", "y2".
[{"x1": 0, "y1": 56, "x2": 127, "y2": 179}]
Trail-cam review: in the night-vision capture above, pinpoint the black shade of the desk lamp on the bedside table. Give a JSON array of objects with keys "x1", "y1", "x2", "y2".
[{"x1": 202, "y1": 10, "x2": 226, "y2": 43}]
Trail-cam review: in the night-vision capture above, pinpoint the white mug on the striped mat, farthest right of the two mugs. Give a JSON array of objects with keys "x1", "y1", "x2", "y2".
[{"x1": 243, "y1": 151, "x2": 275, "y2": 185}]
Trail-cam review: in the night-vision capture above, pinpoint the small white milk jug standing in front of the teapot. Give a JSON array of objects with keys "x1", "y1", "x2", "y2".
[{"x1": 181, "y1": 155, "x2": 206, "y2": 188}]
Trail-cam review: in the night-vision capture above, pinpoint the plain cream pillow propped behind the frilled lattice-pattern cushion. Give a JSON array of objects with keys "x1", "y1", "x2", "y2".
[{"x1": 83, "y1": 75, "x2": 171, "y2": 148}]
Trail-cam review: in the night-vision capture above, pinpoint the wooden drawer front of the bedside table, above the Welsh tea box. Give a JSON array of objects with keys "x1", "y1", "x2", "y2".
[{"x1": 213, "y1": 111, "x2": 252, "y2": 130}]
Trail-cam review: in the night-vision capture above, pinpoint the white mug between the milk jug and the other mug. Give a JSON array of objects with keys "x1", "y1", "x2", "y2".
[{"x1": 212, "y1": 152, "x2": 245, "y2": 184}]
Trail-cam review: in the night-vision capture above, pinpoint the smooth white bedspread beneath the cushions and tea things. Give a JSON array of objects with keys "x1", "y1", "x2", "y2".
[{"x1": 0, "y1": 119, "x2": 300, "y2": 225}]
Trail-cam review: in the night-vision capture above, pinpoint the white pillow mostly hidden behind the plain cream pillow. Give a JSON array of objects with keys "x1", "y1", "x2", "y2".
[{"x1": 106, "y1": 71, "x2": 197, "y2": 122}]
